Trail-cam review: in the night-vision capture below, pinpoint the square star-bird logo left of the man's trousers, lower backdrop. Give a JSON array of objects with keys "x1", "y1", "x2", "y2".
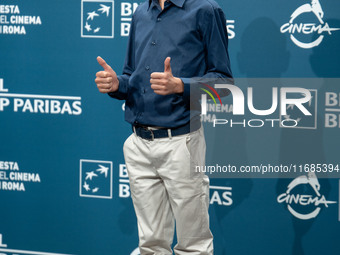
[{"x1": 79, "y1": 159, "x2": 112, "y2": 199}]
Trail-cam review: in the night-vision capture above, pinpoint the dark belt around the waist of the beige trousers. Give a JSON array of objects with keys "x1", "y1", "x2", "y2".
[{"x1": 132, "y1": 122, "x2": 201, "y2": 140}]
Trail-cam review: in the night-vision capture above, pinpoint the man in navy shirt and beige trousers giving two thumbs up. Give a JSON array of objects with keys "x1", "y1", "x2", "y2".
[{"x1": 95, "y1": 0, "x2": 232, "y2": 255}]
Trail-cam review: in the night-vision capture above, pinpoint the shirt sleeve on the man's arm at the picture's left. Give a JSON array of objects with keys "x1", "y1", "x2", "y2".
[{"x1": 108, "y1": 13, "x2": 135, "y2": 100}]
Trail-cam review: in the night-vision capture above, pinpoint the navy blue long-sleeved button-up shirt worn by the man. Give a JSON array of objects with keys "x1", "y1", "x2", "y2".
[{"x1": 109, "y1": 0, "x2": 232, "y2": 128}]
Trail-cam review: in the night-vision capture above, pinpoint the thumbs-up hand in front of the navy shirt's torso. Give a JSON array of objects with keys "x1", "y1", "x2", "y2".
[{"x1": 150, "y1": 57, "x2": 184, "y2": 96}]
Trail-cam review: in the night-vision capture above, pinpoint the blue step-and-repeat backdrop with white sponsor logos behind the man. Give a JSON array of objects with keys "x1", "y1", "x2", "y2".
[{"x1": 0, "y1": 0, "x2": 340, "y2": 255}]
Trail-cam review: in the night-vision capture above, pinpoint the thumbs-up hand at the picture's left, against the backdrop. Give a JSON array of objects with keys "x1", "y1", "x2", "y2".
[{"x1": 95, "y1": 57, "x2": 119, "y2": 93}]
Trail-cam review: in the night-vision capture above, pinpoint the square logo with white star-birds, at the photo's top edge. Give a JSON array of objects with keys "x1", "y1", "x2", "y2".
[{"x1": 81, "y1": 0, "x2": 114, "y2": 38}]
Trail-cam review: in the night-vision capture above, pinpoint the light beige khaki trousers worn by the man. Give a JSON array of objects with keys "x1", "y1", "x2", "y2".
[{"x1": 124, "y1": 128, "x2": 213, "y2": 255}]
